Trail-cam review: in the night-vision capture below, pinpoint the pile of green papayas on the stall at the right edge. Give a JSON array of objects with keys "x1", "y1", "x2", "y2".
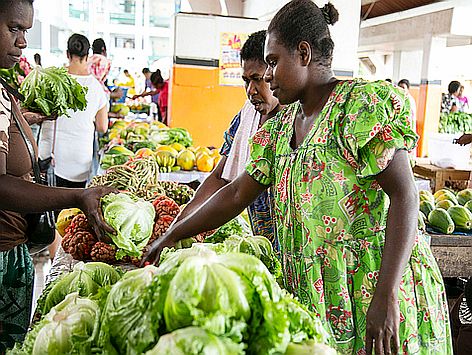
[{"x1": 418, "y1": 189, "x2": 472, "y2": 234}]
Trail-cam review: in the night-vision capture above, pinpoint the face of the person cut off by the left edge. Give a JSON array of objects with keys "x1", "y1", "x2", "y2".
[{"x1": 0, "y1": 1, "x2": 33, "y2": 69}]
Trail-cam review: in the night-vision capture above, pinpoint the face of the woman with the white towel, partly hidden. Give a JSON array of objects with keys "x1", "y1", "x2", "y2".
[{"x1": 242, "y1": 59, "x2": 278, "y2": 115}]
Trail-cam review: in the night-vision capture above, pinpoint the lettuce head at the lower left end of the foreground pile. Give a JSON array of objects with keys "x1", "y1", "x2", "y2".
[{"x1": 10, "y1": 292, "x2": 100, "y2": 355}]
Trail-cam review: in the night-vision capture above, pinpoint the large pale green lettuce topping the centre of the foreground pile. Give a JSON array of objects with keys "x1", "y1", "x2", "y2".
[{"x1": 164, "y1": 255, "x2": 253, "y2": 342}]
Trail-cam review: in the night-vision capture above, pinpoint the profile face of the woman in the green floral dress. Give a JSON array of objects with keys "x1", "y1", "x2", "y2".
[{"x1": 264, "y1": 33, "x2": 304, "y2": 105}]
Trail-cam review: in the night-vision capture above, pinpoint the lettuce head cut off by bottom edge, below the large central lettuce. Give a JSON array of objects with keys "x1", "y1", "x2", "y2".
[{"x1": 146, "y1": 327, "x2": 244, "y2": 355}]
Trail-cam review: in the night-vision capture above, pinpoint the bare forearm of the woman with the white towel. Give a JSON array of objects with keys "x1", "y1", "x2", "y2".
[{"x1": 175, "y1": 156, "x2": 229, "y2": 223}]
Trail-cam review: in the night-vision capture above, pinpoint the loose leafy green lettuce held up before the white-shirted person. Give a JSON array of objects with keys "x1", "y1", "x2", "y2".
[{"x1": 20, "y1": 66, "x2": 87, "y2": 117}]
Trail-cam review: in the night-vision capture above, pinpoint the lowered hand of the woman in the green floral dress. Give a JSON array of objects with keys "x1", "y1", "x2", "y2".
[{"x1": 365, "y1": 294, "x2": 400, "y2": 355}]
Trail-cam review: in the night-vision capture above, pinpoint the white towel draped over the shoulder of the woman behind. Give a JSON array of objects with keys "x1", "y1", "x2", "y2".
[{"x1": 221, "y1": 100, "x2": 261, "y2": 181}]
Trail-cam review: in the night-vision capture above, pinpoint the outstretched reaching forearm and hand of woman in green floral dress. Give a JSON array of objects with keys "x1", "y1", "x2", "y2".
[{"x1": 143, "y1": 172, "x2": 267, "y2": 263}]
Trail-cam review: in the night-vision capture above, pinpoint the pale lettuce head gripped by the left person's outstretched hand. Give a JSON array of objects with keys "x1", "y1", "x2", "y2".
[{"x1": 102, "y1": 193, "x2": 156, "y2": 259}]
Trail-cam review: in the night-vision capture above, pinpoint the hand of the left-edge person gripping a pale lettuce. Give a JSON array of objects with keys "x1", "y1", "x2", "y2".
[{"x1": 79, "y1": 186, "x2": 118, "y2": 243}]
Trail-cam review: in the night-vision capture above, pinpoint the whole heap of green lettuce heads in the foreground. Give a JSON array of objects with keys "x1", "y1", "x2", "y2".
[{"x1": 10, "y1": 239, "x2": 336, "y2": 355}]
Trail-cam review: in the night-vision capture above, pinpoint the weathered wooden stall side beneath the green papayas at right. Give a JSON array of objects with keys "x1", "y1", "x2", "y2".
[{"x1": 431, "y1": 235, "x2": 472, "y2": 277}]
